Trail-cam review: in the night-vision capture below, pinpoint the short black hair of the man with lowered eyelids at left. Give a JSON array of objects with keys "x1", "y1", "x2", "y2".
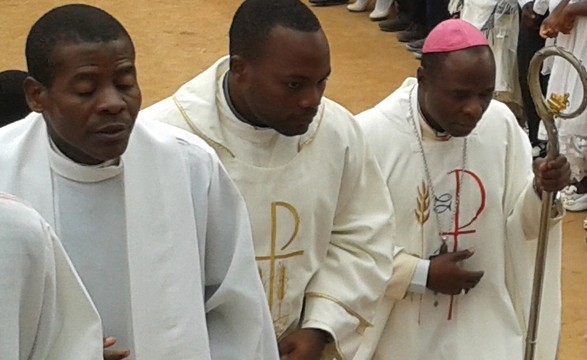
[{"x1": 25, "y1": 4, "x2": 134, "y2": 86}]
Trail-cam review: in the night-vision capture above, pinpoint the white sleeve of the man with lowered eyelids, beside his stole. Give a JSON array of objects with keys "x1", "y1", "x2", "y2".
[{"x1": 200, "y1": 155, "x2": 279, "y2": 360}]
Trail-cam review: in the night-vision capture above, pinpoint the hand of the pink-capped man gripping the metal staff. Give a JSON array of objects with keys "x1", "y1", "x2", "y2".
[{"x1": 534, "y1": 155, "x2": 571, "y2": 194}]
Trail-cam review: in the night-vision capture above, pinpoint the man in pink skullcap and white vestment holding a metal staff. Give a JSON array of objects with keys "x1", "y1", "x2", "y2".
[{"x1": 357, "y1": 20, "x2": 570, "y2": 360}]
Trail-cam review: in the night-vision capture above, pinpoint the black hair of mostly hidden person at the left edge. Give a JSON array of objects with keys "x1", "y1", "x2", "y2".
[{"x1": 0, "y1": 70, "x2": 31, "y2": 127}]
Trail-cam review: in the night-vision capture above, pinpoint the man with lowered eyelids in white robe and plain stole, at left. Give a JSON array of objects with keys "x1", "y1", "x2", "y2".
[{"x1": 0, "y1": 5, "x2": 278, "y2": 360}]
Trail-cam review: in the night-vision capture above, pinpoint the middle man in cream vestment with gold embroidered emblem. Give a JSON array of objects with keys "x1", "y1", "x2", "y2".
[{"x1": 139, "y1": 0, "x2": 393, "y2": 360}]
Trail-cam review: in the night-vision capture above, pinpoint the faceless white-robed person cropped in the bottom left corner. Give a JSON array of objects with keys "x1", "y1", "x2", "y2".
[{"x1": 0, "y1": 193, "x2": 102, "y2": 360}]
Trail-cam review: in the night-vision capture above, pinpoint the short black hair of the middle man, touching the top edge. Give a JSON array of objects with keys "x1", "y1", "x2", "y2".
[{"x1": 229, "y1": 0, "x2": 322, "y2": 59}]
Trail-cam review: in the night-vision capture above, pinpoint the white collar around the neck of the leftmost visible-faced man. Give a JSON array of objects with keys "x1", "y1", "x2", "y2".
[{"x1": 47, "y1": 135, "x2": 123, "y2": 183}]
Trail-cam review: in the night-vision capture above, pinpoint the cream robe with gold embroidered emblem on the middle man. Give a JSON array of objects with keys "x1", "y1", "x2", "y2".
[{"x1": 142, "y1": 58, "x2": 393, "y2": 359}]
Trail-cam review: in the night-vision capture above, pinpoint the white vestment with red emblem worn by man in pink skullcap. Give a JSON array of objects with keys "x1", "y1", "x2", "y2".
[{"x1": 357, "y1": 78, "x2": 561, "y2": 360}]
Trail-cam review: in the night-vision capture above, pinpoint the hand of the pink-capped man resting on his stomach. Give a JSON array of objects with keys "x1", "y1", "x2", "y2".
[{"x1": 426, "y1": 250, "x2": 485, "y2": 295}]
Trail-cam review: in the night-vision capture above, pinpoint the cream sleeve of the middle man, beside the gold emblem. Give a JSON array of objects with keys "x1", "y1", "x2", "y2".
[{"x1": 302, "y1": 119, "x2": 395, "y2": 359}]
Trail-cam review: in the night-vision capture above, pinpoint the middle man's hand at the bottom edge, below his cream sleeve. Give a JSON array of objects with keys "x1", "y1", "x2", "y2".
[{"x1": 278, "y1": 329, "x2": 328, "y2": 360}]
